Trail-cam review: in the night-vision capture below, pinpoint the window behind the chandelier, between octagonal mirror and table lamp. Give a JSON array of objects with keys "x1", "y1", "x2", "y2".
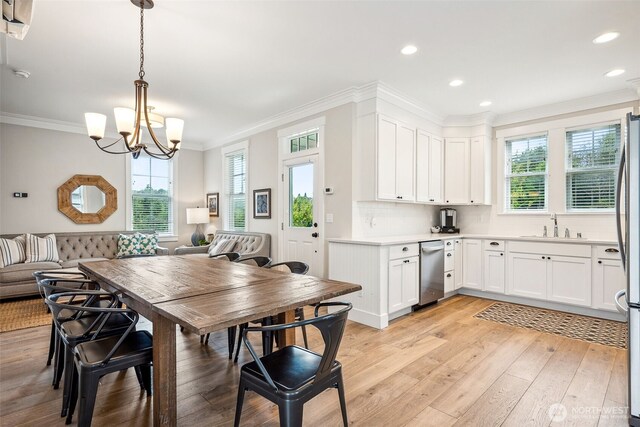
[{"x1": 131, "y1": 155, "x2": 175, "y2": 235}]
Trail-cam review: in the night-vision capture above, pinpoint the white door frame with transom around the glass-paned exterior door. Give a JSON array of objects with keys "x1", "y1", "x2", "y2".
[{"x1": 277, "y1": 116, "x2": 326, "y2": 277}]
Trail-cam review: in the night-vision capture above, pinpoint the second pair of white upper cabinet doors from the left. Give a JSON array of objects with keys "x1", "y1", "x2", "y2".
[{"x1": 416, "y1": 129, "x2": 444, "y2": 203}]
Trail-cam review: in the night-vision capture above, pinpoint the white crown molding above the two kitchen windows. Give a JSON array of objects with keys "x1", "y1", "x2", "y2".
[{"x1": 493, "y1": 89, "x2": 640, "y2": 127}]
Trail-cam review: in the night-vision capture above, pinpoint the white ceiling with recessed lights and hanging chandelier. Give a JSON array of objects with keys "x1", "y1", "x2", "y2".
[{"x1": 0, "y1": 0, "x2": 640, "y2": 148}]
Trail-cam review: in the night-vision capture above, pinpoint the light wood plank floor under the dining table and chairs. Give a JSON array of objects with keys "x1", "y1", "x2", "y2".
[{"x1": 0, "y1": 296, "x2": 627, "y2": 426}]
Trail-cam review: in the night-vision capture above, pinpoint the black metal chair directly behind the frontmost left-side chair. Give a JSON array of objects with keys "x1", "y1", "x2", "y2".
[{"x1": 38, "y1": 288, "x2": 135, "y2": 417}]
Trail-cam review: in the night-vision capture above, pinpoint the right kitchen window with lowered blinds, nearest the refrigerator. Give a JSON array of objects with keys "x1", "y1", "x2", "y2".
[{"x1": 566, "y1": 124, "x2": 620, "y2": 211}]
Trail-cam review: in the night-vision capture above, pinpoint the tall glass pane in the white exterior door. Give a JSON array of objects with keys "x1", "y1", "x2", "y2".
[{"x1": 289, "y1": 163, "x2": 313, "y2": 227}]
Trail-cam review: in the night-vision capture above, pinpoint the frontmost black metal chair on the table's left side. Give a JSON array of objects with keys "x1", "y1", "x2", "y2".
[{"x1": 47, "y1": 291, "x2": 153, "y2": 426}]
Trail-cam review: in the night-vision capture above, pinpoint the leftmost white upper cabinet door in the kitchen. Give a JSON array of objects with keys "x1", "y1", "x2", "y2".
[{"x1": 376, "y1": 116, "x2": 398, "y2": 200}]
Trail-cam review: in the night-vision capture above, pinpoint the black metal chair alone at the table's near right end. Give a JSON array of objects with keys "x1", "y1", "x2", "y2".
[{"x1": 234, "y1": 302, "x2": 351, "y2": 427}]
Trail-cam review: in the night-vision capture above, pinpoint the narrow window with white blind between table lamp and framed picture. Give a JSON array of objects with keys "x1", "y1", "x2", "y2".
[{"x1": 225, "y1": 150, "x2": 247, "y2": 231}]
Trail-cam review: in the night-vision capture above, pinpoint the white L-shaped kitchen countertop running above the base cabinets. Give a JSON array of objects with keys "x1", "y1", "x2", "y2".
[{"x1": 327, "y1": 233, "x2": 618, "y2": 247}]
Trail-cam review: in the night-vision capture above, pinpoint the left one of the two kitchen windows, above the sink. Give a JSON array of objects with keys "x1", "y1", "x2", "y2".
[{"x1": 504, "y1": 135, "x2": 547, "y2": 212}]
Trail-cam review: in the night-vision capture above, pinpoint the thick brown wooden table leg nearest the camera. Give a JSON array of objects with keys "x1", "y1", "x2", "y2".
[{"x1": 152, "y1": 312, "x2": 177, "y2": 427}]
